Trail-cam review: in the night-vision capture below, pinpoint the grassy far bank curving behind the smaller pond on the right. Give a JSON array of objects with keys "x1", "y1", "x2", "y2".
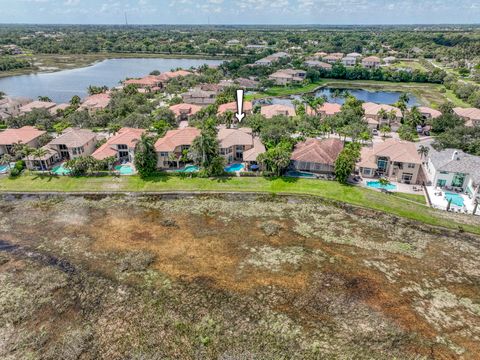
[{"x1": 246, "y1": 79, "x2": 469, "y2": 107}]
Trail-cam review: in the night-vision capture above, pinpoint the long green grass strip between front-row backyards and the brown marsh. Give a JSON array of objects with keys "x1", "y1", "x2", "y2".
[{"x1": 0, "y1": 175, "x2": 480, "y2": 234}]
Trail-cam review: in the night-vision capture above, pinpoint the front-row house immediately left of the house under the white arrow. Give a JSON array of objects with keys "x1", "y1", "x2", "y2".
[{"x1": 155, "y1": 127, "x2": 200, "y2": 169}]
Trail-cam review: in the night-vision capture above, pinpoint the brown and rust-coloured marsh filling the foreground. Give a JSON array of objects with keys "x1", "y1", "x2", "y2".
[{"x1": 0, "y1": 194, "x2": 480, "y2": 359}]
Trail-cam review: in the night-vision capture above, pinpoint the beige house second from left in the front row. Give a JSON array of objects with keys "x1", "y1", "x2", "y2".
[{"x1": 48, "y1": 128, "x2": 97, "y2": 160}]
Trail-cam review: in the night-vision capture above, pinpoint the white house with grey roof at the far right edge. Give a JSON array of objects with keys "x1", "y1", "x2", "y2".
[{"x1": 425, "y1": 149, "x2": 480, "y2": 200}]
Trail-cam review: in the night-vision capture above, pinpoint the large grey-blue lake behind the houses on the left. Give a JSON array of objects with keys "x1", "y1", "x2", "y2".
[{"x1": 0, "y1": 58, "x2": 222, "y2": 103}]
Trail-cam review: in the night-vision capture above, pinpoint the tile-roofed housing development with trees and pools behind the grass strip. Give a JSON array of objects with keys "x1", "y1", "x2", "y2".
[{"x1": 0, "y1": 40, "x2": 480, "y2": 213}]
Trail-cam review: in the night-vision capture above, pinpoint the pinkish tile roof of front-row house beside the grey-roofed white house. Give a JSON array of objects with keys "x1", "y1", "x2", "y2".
[{"x1": 358, "y1": 139, "x2": 422, "y2": 168}]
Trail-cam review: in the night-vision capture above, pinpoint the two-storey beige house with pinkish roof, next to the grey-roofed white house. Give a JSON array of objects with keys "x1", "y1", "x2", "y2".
[{"x1": 357, "y1": 139, "x2": 422, "y2": 184}]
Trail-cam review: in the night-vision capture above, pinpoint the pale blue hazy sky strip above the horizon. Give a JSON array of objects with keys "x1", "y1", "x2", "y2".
[{"x1": 0, "y1": 0, "x2": 480, "y2": 25}]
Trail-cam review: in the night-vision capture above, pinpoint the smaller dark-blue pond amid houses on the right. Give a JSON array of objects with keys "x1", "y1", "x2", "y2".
[{"x1": 258, "y1": 87, "x2": 421, "y2": 106}]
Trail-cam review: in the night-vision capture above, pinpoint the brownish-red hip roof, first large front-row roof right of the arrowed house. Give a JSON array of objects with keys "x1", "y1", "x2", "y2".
[{"x1": 291, "y1": 138, "x2": 343, "y2": 165}]
